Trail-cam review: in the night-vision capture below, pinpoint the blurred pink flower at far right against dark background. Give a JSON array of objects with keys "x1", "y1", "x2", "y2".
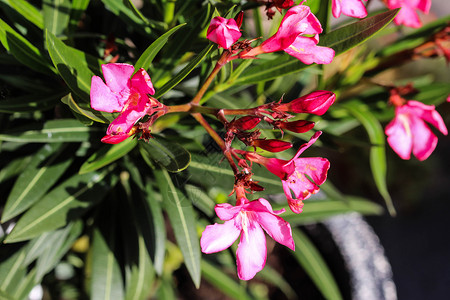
[{"x1": 385, "y1": 100, "x2": 447, "y2": 161}]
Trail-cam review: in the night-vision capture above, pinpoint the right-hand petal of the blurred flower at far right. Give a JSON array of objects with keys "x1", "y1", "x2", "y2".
[{"x1": 410, "y1": 118, "x2": 438, "y2": 161}]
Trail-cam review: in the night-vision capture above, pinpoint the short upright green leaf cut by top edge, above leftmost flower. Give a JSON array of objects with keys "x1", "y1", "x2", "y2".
[{"x1": 42, "y1": 0, "x2": 72, "y2": 35}]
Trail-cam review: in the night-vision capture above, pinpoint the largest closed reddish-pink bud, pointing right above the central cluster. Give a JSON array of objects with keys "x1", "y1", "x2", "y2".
[{"x1": 278, "y1": 91, "x2": 336, "y2": 116}]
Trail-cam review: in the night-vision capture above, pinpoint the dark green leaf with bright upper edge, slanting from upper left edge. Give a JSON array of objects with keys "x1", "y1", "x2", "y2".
[{"x1": 0, "y1": 19, "x2": 55, "y2": 74}]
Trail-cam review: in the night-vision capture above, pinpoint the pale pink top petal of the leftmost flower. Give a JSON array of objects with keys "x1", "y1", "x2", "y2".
[{"x1": 102, "y1": 63, "x2": 134, "y2": 93}]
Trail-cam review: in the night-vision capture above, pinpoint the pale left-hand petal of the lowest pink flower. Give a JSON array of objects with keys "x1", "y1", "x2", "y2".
[{"x1": 200, "y1": 220, "x2": 241, "y2": 254}]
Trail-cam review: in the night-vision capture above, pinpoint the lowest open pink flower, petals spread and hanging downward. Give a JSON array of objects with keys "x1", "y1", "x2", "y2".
[{"x1": 200, "y1": 198, "x2": 295, "y2": 280}]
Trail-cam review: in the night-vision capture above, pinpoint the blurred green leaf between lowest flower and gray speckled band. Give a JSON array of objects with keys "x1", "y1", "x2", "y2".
[{"x1": 291, "y1": 229, "x2": 342, "y2": 300}]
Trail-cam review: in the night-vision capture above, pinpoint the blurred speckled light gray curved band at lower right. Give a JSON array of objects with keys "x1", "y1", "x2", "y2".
[{"x1": 323, "y1": 213, "x2": 397, "y2": 300}]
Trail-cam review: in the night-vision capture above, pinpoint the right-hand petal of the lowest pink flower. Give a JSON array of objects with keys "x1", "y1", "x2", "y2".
[{"x1": 247, "y1": 198, "x2": 295, "y2": 251}]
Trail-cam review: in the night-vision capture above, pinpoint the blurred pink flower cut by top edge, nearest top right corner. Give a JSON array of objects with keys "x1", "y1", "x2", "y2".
[{"x1": 385, "y1": 0, "x2": 431, "y2": 28}]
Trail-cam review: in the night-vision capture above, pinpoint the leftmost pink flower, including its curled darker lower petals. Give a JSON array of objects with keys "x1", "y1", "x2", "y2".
[{"x1": 91, "y1": 63, "x2": 156, "y2": 144}]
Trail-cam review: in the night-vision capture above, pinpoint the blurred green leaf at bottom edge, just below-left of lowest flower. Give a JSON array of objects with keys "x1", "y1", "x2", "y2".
[{"x1": 202, "y1": 260, "x2": 252, "y2": 299}]
